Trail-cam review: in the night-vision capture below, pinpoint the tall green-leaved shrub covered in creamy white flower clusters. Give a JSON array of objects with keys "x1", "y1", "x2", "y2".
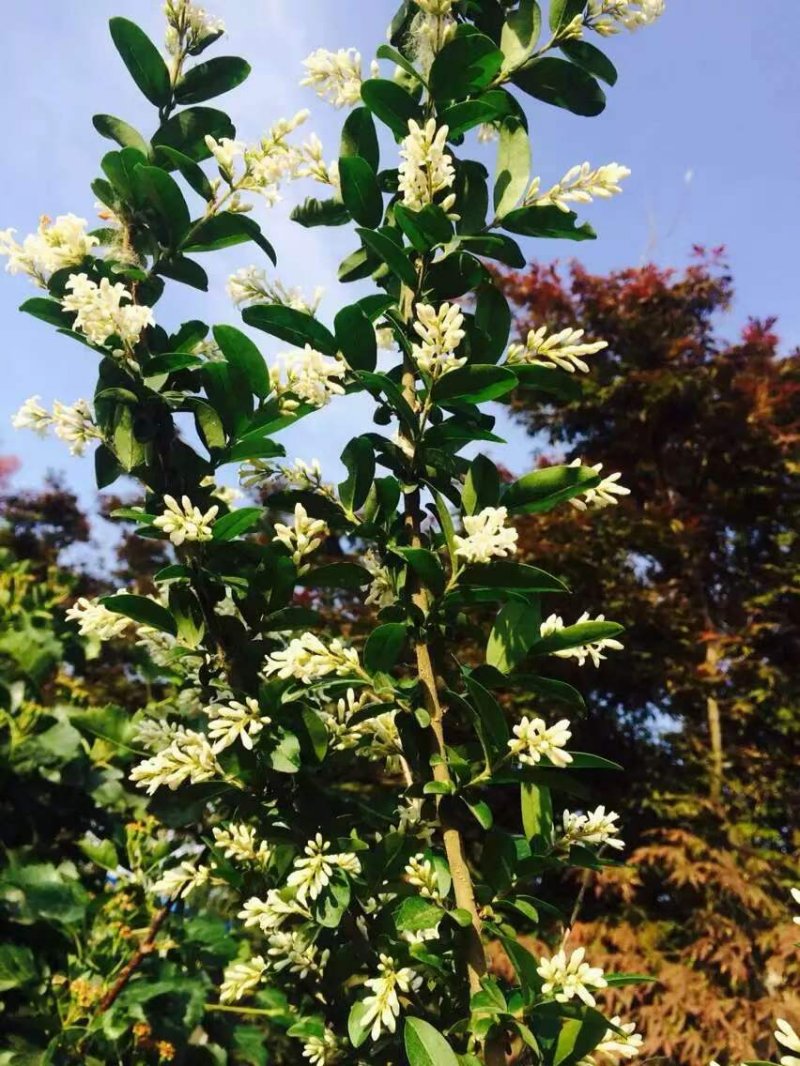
[{"x1": 10, "y1": 0, "x2": 772, "y2": 1066}]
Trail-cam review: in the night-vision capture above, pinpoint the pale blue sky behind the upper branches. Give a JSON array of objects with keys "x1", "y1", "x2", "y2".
[{"x1": 0, "y1": 0, "x2": 800, "y2": 520}]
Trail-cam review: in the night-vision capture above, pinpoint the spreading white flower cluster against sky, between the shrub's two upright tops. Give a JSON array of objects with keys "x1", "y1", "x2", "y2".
[{"x1": 206, "y1": 111, "x2": 308, "y2": 211}]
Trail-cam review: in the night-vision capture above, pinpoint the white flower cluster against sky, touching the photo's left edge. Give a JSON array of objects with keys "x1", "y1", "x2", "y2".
[{"x1": 0, "y1": 214, "x2": 100, "y2": 289}]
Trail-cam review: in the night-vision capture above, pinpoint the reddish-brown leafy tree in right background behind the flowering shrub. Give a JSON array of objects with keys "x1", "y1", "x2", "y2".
[{"x1": 505, "y1": 249, "x2": 800, "y2": 1064}]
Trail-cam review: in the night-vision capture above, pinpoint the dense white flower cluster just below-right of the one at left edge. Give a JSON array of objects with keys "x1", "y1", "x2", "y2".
[{"x1": 61, "y1": 274, "x2": 155, "y2": 350}]
